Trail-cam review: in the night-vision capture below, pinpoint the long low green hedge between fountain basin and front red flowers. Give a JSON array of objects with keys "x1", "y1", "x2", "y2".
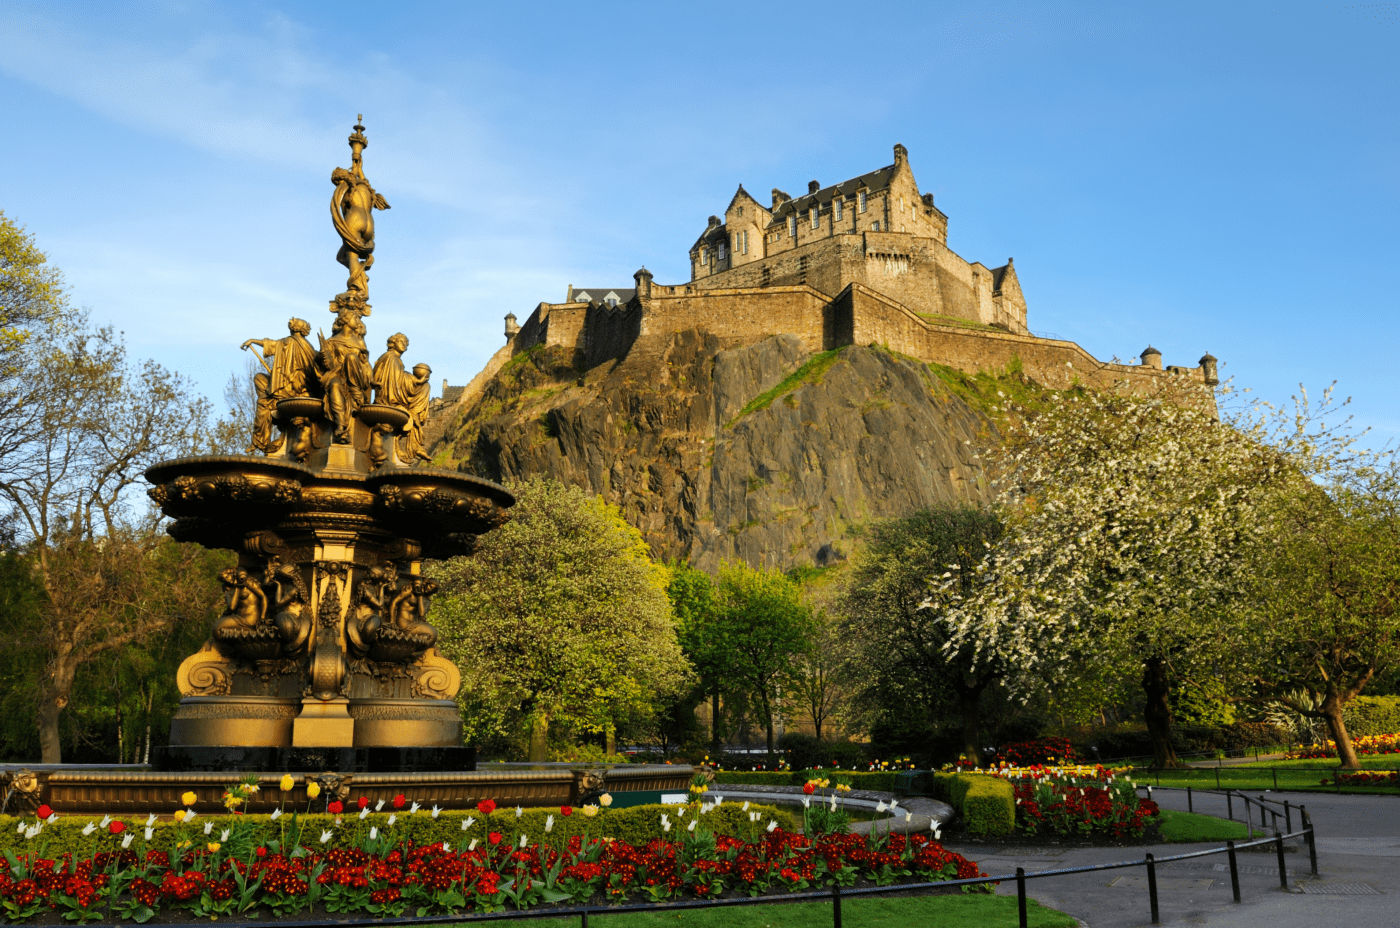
[{"x1": 0, "y1": 802, "x2": 801, "y2": 857}]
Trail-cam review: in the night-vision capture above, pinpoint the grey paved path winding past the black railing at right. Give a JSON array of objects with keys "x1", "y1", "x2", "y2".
[{"x1": 713, "y1": 784, "x2": 1400, "y2": 928}]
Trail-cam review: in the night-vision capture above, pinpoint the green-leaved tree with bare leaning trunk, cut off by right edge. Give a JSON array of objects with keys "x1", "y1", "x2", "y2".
[{"x1": 1259, "y1": 452, "x2": 1400, "y2": 768}]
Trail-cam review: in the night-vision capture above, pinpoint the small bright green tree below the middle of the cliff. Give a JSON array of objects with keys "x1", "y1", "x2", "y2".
[{"x1": 703, "y1": 563, "x2": 812, "y2": 754}]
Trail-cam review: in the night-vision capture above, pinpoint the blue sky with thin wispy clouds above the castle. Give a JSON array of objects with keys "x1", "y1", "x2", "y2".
[{"x1": 0, "y1": 1, "x2": 1400, "y2": 441}]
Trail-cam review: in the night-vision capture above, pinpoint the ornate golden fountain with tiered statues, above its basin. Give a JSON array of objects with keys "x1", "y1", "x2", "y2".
[{"x1": 146, "y1": 123, "x2": 514, "y2": 770}]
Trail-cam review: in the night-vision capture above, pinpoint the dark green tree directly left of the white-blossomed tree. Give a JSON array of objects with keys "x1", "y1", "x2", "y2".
[{"x1": 840, "y1": 504, "x2": 1008, "y2": 760}]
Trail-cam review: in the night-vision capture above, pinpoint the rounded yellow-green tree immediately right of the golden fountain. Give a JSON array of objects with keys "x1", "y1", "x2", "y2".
[{"x1": 431, "y1": 480, "x2": 690, "y2": 760}]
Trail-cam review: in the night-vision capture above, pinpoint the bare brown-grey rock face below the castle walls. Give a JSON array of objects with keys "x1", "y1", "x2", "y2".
[{"x1": 437, "y1": 330, "x2": 993, "y2": 570}]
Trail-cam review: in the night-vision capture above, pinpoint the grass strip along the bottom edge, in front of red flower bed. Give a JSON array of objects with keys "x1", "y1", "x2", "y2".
[{"x1": 420, "y1": 894, "x2": 1079, "y2": 928}]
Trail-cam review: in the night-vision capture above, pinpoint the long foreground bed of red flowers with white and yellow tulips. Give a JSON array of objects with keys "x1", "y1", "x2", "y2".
[{"x1": 0, "y1": 802, "x2": 983, "y2": 922}]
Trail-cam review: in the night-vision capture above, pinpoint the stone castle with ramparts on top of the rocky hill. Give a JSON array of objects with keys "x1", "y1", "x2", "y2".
[{"x1": 442, "y1": 146, "x2": 1218, "y2": 431}]
